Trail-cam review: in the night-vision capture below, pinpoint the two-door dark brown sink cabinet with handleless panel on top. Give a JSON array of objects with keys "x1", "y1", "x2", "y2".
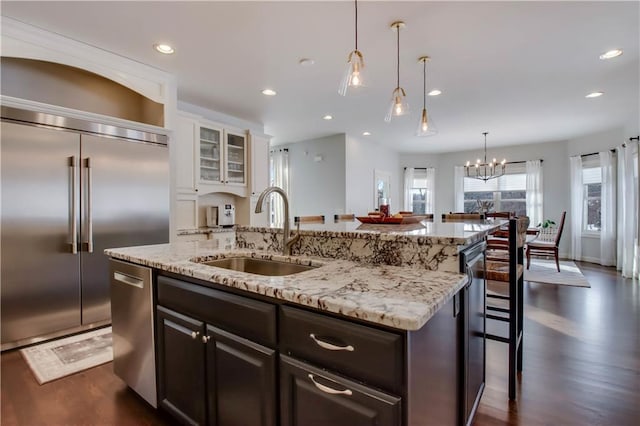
[{"x1": 156, "y1": 277, "x2": 277, "y2": 426}]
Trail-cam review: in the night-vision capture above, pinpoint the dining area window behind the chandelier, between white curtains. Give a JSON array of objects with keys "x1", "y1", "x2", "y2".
[{"x1": 464, "y1": 172, "x2": 527, "y2": 216}]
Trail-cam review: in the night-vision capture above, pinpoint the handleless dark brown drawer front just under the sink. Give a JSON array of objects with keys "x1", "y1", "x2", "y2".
[{"x1": 158, "y1": 277, "x2": 276, "y2": 347}]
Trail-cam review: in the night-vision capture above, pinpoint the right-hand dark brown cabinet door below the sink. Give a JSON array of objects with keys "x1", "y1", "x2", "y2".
[{"x1": 207, "y1": 325, "x2": 276, "y2": 426}]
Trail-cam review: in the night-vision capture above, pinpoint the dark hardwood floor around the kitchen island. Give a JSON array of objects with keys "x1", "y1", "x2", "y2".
[{"x1": 0, "y1": 263, "x2": 640, "y2": 426}]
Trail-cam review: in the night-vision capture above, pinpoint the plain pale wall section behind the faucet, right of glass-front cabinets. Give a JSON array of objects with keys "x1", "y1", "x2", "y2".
[{"x1": 274, "y1": 133, "x2": 346, "y2": 221}]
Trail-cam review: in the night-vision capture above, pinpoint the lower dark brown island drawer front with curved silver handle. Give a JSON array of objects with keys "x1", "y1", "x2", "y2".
[{"x1": 280, "y1": 355, "x2": 401, "y2": 426}]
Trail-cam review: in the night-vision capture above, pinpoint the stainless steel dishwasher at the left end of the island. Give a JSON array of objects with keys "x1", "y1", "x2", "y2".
[{"x1": 109, "y1": 259, "x2": 158, "y2": 408}]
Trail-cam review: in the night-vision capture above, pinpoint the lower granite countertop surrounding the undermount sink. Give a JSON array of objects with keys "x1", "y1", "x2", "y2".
[{"x1": 105, "y1": 241, "x2": 467, "y2": 330}]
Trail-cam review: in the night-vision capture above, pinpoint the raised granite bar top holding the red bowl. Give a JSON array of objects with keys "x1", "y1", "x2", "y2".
[{"x1": 236, "y1": 220, "x2": 505, "y2": 246}]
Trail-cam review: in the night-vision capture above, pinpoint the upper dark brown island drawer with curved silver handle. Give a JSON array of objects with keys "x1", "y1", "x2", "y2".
[{"x1": 280, "y1": 306, "x2": 404, "y2": 393}]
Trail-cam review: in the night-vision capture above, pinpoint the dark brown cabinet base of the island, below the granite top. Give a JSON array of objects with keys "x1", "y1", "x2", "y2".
[{"x1": 156, "y1": 268, "x2": 485, "y2": 426}]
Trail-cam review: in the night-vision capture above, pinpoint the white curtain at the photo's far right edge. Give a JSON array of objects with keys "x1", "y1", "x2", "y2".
[{"x1": 616, "y1": 141, "x2": 640, "y2": 278}]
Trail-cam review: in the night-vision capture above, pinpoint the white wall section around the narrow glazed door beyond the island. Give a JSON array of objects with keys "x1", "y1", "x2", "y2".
[{"x1": 346, "y1": 135, "x2": 402, "y2": 216}]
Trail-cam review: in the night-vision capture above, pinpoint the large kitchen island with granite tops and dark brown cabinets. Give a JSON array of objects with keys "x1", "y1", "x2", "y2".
[{"x1": 106, "y1": 224, "x2": 497, "y2": 426}]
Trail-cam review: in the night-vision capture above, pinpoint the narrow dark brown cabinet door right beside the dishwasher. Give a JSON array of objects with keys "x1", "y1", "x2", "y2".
[{"x1": 157, "y1": 306, "x2": 206, "y2": 425}]
